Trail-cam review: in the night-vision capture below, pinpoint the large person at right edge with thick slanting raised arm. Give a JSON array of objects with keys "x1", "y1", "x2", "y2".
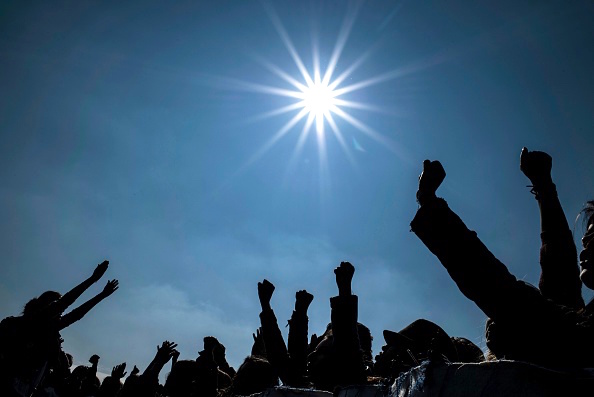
[{"x1": 411, "y1": 160, "x2": 594, "y2": 367}]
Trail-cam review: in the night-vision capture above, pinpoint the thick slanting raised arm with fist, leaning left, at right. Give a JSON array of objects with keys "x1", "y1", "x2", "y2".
[{"x1": 411, "y1": 160, "x2": 540, "y2": 321}]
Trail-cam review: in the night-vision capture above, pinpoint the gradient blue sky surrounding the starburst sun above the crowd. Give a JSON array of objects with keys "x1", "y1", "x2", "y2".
[{"x1": 0, "y1": 0, "x2": 594, "y2": 378}]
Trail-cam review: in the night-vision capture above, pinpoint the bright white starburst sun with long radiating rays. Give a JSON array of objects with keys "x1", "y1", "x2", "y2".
[{"x1": 227, "y1": 1, "x2": 403, "y2": 172}]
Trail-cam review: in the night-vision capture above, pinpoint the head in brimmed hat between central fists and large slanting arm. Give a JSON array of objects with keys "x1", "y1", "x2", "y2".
[{"x1": 374, "y1": 319, "x2": 457, "y2": 378}]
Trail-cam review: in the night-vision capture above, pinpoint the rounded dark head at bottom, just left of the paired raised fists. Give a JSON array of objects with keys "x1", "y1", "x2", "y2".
[{"x1": 231, "y1": 356, "x2": 278, "y2": 396}]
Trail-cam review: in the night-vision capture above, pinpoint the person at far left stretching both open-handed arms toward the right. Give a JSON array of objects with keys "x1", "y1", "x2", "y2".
[{"x1": 0, "y1": 261, "x2": 118, "y2": 396}]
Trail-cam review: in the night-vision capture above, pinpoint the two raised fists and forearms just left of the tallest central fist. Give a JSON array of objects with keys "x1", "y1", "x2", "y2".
[{"x1": 258, "y1": 280, "x2": 313, "y2": 387}]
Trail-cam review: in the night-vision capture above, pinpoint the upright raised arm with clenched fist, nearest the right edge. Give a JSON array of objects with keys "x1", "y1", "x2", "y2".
[{"x1": 520, "y1": 148, "x2": 584, "y2": 308}]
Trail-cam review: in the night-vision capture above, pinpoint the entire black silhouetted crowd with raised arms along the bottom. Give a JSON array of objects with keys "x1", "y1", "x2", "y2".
[{"x1": 0, "y1": 148, "x2": 594, "y2": 397}]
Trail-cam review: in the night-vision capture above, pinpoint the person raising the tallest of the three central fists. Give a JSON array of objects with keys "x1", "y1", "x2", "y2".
[{"x1": 308, "y1": 262, "x2": 369, "y2": 391}]
